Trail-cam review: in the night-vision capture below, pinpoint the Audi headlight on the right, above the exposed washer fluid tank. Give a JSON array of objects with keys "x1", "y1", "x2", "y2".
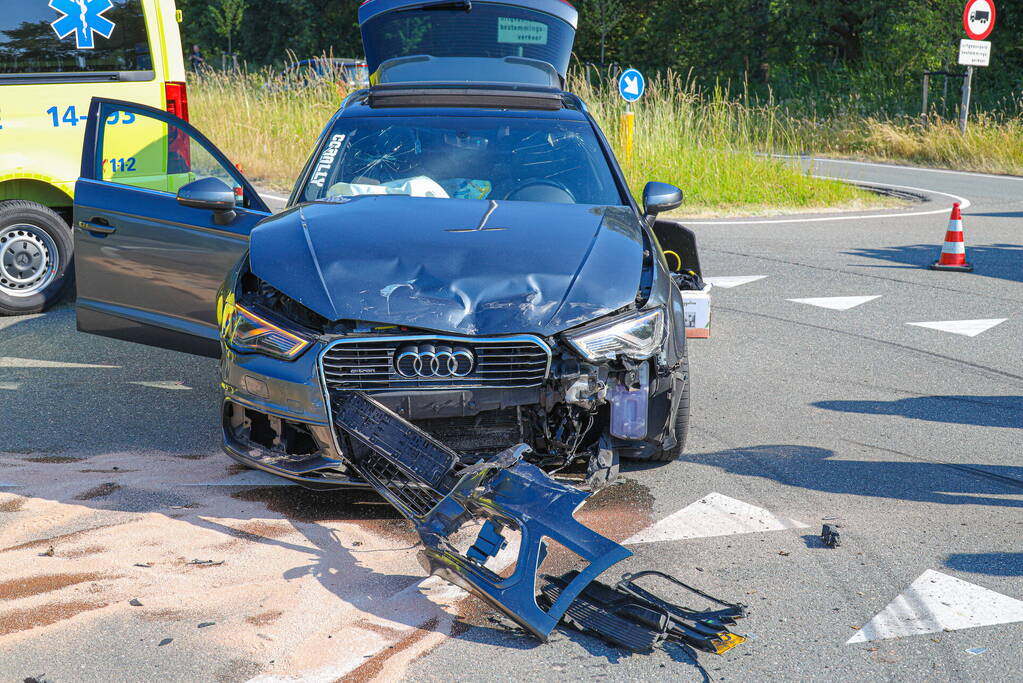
[{"x1": 565, "y1": 308, "x2": 664, "y2": 361}]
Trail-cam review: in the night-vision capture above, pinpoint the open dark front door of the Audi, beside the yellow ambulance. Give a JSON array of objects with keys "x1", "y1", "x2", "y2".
[{"x1": 74, "y1": 97, "x2": 270, "y2": 358}]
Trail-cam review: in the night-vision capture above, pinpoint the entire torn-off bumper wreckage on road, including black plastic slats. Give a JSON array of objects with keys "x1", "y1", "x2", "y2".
[{"x1": 330, "y1": 392, "x2": 745, "y2": 653}]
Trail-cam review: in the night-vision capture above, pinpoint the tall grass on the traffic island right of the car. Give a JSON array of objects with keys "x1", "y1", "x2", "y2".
[{"x1": 568, "y1": 73, "x2": 863, "y2": 215}]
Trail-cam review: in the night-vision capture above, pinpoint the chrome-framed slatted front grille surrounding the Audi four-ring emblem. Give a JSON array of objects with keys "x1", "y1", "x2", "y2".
[{"x1": 320, "y1": 335, "x2": 550, "y2": 392}]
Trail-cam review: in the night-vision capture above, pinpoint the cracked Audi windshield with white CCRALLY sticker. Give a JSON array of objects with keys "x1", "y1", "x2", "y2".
[{"x1": 302, "y1": 117, "x2": 624, "y2": 206}]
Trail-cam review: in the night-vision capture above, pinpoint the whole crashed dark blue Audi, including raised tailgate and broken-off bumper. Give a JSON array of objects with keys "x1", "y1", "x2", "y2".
[{"x1": 75, "y1": 0, "x2": 744, "y2": 647}]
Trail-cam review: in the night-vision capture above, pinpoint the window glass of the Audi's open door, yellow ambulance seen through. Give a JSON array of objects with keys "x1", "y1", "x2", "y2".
[{"x1": 96, "y1": 103, "x2": 246, "y2": 199}]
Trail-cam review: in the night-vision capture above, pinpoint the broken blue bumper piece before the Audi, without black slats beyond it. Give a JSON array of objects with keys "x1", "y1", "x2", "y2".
[{"x1": 331, "y1": 392, "x2": 632, "y2": 640}]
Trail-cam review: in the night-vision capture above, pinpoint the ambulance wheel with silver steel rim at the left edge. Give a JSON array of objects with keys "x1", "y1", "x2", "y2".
[{"x1": 0, "y1": 199, "x2": 74, "y2": 316}]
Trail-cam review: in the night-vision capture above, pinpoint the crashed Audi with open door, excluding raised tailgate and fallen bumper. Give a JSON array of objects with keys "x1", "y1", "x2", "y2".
[{"x1": 70, "y1": 80, "x2": 695, "y2": 488}]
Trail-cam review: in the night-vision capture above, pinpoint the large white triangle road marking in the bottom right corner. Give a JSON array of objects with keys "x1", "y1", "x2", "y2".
[{"x1": 845, "y1": 570, "x2": 1023, "y2": 645}]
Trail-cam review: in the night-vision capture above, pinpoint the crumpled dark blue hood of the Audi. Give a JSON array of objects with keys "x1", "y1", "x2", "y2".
[{"x1": 250, "y1": 196, "x2": 643, "y2": 335}]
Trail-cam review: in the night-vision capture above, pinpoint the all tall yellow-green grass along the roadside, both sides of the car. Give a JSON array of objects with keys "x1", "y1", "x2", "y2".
[{"x1": 189, "y1": 66, "x2": 1023, "y2": 215}]
